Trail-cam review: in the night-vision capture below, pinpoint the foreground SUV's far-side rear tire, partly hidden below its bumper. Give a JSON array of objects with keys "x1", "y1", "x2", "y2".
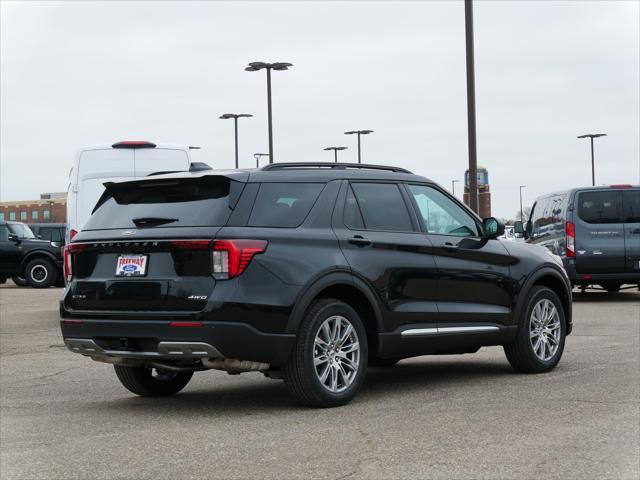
[{"x1": 113, "y1": 365, "x2": 193, "y2": 397}]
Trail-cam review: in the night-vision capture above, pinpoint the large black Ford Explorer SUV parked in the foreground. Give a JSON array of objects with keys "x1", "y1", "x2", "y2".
[{"x1": 60, "y1": 163, "x2": 572, "y2": 407}]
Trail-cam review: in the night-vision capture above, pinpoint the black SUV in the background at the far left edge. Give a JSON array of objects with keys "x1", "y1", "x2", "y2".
[{"x1": 0, "y1": 221, "x2": 62, "y2": 288}]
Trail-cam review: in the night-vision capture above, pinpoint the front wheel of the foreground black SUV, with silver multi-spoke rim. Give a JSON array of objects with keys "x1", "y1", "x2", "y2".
[{"x1": 504, "y1": 286, "x2": 566, "y2": 373}]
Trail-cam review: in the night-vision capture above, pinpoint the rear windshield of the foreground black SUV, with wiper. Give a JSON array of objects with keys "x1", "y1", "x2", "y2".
[{"x1": 83, "y1": 176, "x2": 236, "y2": 230}]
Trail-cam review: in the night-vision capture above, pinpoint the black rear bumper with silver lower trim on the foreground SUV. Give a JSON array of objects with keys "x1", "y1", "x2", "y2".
[{"x1": 60, "y1": 320, "x2": 295, "y2": 365}]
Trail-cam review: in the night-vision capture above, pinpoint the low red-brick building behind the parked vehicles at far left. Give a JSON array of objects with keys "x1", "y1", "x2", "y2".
[{"x1": 0, "y1": 192, "x2": 67, "y2": 223}]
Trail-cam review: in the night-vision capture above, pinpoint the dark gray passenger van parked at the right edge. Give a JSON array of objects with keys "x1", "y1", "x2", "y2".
[{"x1": 515, "y1": 185, "x2": 640, "y2": 292}]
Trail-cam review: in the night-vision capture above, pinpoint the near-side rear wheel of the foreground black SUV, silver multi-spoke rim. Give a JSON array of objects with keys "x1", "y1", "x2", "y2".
[{"x1": 282, "y1": 299, "x2": 368, "y2": 408}]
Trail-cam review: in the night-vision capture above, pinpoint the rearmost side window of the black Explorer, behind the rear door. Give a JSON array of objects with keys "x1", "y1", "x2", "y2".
[{"x1": 248, "y1": 183, "x2": 325, "y2": 228}]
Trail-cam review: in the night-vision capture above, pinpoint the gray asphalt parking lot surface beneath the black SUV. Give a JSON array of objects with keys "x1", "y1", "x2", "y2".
[{"x1": 0, "y1": 282, "x2": 640, "y2": 480}]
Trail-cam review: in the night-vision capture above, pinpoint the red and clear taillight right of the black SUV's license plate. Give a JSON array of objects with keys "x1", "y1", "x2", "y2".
[{"x1": 212, "y1": 240, "x2": 267, "y2": 280}]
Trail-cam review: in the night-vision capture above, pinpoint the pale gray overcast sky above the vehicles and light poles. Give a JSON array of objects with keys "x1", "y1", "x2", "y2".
[{"x1": 0, "y1": 1, "x2": 640, "y2": 217}]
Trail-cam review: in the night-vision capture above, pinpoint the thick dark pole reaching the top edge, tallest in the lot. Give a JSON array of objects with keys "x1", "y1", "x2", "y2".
[{"x1": 464, "y1": 0, "x2": 478, "y2": 213}]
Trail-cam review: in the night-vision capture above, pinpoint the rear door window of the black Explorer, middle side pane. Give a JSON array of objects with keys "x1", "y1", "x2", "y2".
[{"x1": 351, "y1": 182, "x2": 414, "y2": 232}]
